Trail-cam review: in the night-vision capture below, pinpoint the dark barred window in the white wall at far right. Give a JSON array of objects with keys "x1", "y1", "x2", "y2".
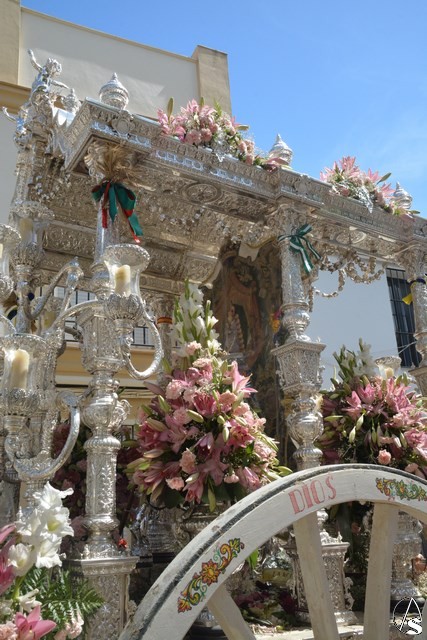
[{"x1": 387, "y1": 269, "x2": 421, "y2": 367}]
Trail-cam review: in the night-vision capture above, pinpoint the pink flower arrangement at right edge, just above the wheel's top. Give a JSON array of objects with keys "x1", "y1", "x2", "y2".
[{"x1": 317, "y1": 342, "x2": 427, "y2": 479}]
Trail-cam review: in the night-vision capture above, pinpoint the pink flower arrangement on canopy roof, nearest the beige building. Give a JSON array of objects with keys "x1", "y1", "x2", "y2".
[{"x1": 158, "y1": 98, "x2": 285, "y2": 171}]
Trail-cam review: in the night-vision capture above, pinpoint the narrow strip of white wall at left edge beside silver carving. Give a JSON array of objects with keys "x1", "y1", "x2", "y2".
[{"x1": 0, "y1": 115, "x2": 16, "y2": 223}]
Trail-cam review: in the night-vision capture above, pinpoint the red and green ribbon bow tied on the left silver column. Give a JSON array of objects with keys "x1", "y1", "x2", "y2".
[{"x1": 92, "y1": 180, "x2": 143, "y2": 242}]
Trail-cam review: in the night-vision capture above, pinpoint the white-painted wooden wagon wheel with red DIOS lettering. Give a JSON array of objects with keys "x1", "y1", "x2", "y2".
[{"x1": 120, "y1": 465, "x2": 427, "y2": 640}]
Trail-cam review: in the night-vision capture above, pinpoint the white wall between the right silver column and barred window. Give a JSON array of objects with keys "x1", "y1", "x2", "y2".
[{"x1": 307, "y1": 273, "x2": 397, "y2": 388}]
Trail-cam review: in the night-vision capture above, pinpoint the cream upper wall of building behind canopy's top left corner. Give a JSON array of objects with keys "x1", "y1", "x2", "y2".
[{"x1": 19, "y1": 8, "x2": 199, "y2": 117}]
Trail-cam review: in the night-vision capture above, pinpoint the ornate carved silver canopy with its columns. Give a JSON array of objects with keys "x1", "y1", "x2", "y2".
[{"x1": 0, "y1": 45, "x2": 427, "y2": 638}]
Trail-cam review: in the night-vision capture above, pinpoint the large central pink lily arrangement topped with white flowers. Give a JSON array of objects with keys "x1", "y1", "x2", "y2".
[{"x1": 128, "y1": 283, "x2": 289, "y2": 510}]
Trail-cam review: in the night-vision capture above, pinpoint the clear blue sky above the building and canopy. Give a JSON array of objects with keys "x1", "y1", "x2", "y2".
[{"x1": 22, "y1": 0, "x2": 427, "y2": 217}]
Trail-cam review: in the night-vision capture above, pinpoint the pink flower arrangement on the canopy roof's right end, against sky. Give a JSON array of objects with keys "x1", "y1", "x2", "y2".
[{"x1": 320, "y1": 156, "x2": 419, "y2": 217}]
